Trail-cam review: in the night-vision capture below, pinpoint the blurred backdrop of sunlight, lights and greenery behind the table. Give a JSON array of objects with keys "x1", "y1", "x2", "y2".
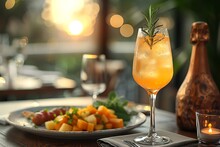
[{"x1": 0, "y1": 0, "x2": 220, "y2": 112}]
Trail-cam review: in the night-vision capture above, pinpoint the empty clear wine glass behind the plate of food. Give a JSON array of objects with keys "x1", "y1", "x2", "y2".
[{"x1": 80, "y1": 54, "x2": 106, "y2": 102}]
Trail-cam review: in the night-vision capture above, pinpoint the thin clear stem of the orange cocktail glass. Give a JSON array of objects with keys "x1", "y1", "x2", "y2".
[{"x1": 148, "y1": 94, "x2": 157, "y2": 138}]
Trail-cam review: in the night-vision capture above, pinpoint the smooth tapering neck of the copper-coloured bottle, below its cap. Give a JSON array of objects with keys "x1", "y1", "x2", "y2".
[{"x1": 188, "y1": 42, "x2": 210, "y2": 74}]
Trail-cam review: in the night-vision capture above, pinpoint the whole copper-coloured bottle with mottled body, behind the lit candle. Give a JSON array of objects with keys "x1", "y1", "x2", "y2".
[{"x1": 176, "y1": 22, "x2": 220, "y2": 131}]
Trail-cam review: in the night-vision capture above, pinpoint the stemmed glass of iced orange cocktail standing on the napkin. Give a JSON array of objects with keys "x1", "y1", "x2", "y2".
[{"x1": 132, "y1": 27, "x2": 173, "y2": 145}]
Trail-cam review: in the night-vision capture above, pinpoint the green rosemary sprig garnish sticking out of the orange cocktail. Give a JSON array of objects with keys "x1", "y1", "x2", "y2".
[{"x1": 142, "y1": 5, "x2": 164, "y2": 49}]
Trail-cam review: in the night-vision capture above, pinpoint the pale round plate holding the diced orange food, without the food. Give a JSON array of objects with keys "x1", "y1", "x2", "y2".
[{"x1": 7, "y1": 106, "x2": 146, "y2": 139}]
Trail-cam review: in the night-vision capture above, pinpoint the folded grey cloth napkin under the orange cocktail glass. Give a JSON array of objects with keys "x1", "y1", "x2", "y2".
[{"x1": 97, "y1": 131, "x2": 198, "y2": 147}]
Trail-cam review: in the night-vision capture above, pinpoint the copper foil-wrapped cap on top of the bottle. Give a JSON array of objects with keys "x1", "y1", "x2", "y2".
[{"x1": 190, "y1": 22, "x2": 209, "y2": 43}]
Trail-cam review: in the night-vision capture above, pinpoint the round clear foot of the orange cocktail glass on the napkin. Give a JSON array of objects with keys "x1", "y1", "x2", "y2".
[{"x1": 134, "y1": 136, "x2": 170, "y2": 145}]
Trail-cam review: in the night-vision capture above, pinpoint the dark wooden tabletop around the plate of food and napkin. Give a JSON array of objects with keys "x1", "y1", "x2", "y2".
[{"x1": 0, "y1": 97, "x2": 196, "y2": 147}]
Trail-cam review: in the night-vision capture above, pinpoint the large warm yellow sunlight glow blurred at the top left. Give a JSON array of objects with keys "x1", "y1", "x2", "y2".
[{"x1": 41, "y1": 0, "x2": 100, "y2": 37}]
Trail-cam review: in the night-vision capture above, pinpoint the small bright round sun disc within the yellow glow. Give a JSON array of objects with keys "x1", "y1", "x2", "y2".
[{"x1": 69, "y1": 20, "x2": 83, "y2": 35}]
